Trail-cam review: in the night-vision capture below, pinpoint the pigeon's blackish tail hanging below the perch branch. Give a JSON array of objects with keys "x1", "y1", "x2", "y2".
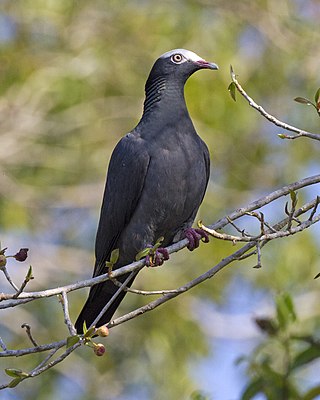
[{"x1": 75, "y1": 275, "x2": 136, "y2": 334}]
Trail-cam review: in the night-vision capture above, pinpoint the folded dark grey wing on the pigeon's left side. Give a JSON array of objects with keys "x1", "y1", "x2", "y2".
[{"x1": 93, "y1": 134, "x2": 150, "y2": 276}]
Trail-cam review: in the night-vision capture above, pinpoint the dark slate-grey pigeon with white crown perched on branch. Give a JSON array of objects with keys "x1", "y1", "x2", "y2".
[{"x1": 75, "y1": 49, "x2": 219, "y2": 334}]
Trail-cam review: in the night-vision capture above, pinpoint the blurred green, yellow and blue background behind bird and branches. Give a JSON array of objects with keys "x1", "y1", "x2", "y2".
[{"x1": 0, "y1": 0, "x2": 320, "y2": 400}]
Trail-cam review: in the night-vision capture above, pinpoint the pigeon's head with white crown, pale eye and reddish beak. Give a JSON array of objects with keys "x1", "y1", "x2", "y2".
[{"x1": 149, "y1": 49, "x2": 218, "y2": 84}]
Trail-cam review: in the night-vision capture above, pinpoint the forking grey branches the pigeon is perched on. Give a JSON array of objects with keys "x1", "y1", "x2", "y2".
[{"x1": 0, "y1": 174, "x2": 320, "y2": 389}]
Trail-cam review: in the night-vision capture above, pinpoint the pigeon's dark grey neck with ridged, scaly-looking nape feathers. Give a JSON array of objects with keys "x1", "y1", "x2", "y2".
[{"x1": 142, "y1": 77, "x2": 189, "y2": 119}]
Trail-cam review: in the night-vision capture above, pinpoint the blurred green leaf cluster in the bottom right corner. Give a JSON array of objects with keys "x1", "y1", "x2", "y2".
[{"x1": 239, "y1": 293, "x2": 320, "y2": 400}]
